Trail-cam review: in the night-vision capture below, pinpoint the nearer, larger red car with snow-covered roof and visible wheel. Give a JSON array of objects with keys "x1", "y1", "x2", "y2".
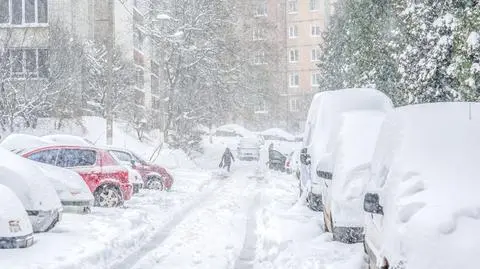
[{"x1": 20, "y1": 145, "x2": 133, "y2": 207}]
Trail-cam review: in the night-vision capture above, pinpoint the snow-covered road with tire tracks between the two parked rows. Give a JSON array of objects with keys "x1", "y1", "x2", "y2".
[{"x1": 0, "y1": 160, "x2": 363, "y2": 269}]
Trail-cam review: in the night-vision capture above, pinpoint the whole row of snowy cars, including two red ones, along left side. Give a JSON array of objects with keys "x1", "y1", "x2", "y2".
[{"x1": 0, "y1": 134, "x2": 173, "y2": 248}]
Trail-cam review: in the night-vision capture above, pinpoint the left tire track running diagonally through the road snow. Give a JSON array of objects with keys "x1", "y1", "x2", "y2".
[{"x1": 109, "y1": 176, "x2": 225, "y2": 269}]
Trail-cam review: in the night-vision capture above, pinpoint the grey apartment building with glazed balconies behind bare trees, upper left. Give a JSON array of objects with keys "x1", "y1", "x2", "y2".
[{"x1": 0, "y1": 0, "x2": 161, "y2": 125}]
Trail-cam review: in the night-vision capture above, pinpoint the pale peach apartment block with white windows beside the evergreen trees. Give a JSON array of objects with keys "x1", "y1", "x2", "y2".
[{"x1": 285, "y1": 0, "x2": 329, "y2": 129}]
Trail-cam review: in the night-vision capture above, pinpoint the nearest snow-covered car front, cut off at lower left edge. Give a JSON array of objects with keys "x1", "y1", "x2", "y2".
[{"x1": 0, "y1": 184, "x2": 33, "y2": 249}]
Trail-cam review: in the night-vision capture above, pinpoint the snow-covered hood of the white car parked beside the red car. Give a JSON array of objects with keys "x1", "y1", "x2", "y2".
[{"x1": 35, "y1": 163, "x2": 93, "y2": 201}]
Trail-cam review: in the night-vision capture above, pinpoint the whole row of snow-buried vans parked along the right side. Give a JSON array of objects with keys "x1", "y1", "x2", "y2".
[{"x1": 299, "y1": 89, "x2": 480, "y2": 268}]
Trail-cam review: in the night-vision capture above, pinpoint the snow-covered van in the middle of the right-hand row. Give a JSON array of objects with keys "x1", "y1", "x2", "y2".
[{"x1": 317, "y1": 110, "x2": 385, "y2": 243}]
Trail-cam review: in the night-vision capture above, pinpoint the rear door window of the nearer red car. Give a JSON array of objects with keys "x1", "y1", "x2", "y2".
[{"x1": 57, "y1": 149, "x2": 97, "y2": 167}]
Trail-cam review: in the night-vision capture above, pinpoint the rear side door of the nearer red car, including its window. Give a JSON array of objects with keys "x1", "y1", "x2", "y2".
[{"x1": 57, "y1": 148, "x2": 102, "y2": 192}]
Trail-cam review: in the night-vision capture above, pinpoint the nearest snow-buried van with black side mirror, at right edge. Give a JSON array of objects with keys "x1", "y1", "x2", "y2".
[{"x1": 364, "y1": 103, "x2": 480, "y2": 269}]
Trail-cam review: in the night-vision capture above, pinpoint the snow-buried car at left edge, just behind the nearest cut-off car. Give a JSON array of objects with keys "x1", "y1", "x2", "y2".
[{"x1": 0, "y1": 148, "x2": 63, "y2": 232}]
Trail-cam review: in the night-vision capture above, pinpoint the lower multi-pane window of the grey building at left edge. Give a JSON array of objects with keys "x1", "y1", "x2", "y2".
[{"x1": 8, "y1": 49, "x2": 48, "y2": 78}]
